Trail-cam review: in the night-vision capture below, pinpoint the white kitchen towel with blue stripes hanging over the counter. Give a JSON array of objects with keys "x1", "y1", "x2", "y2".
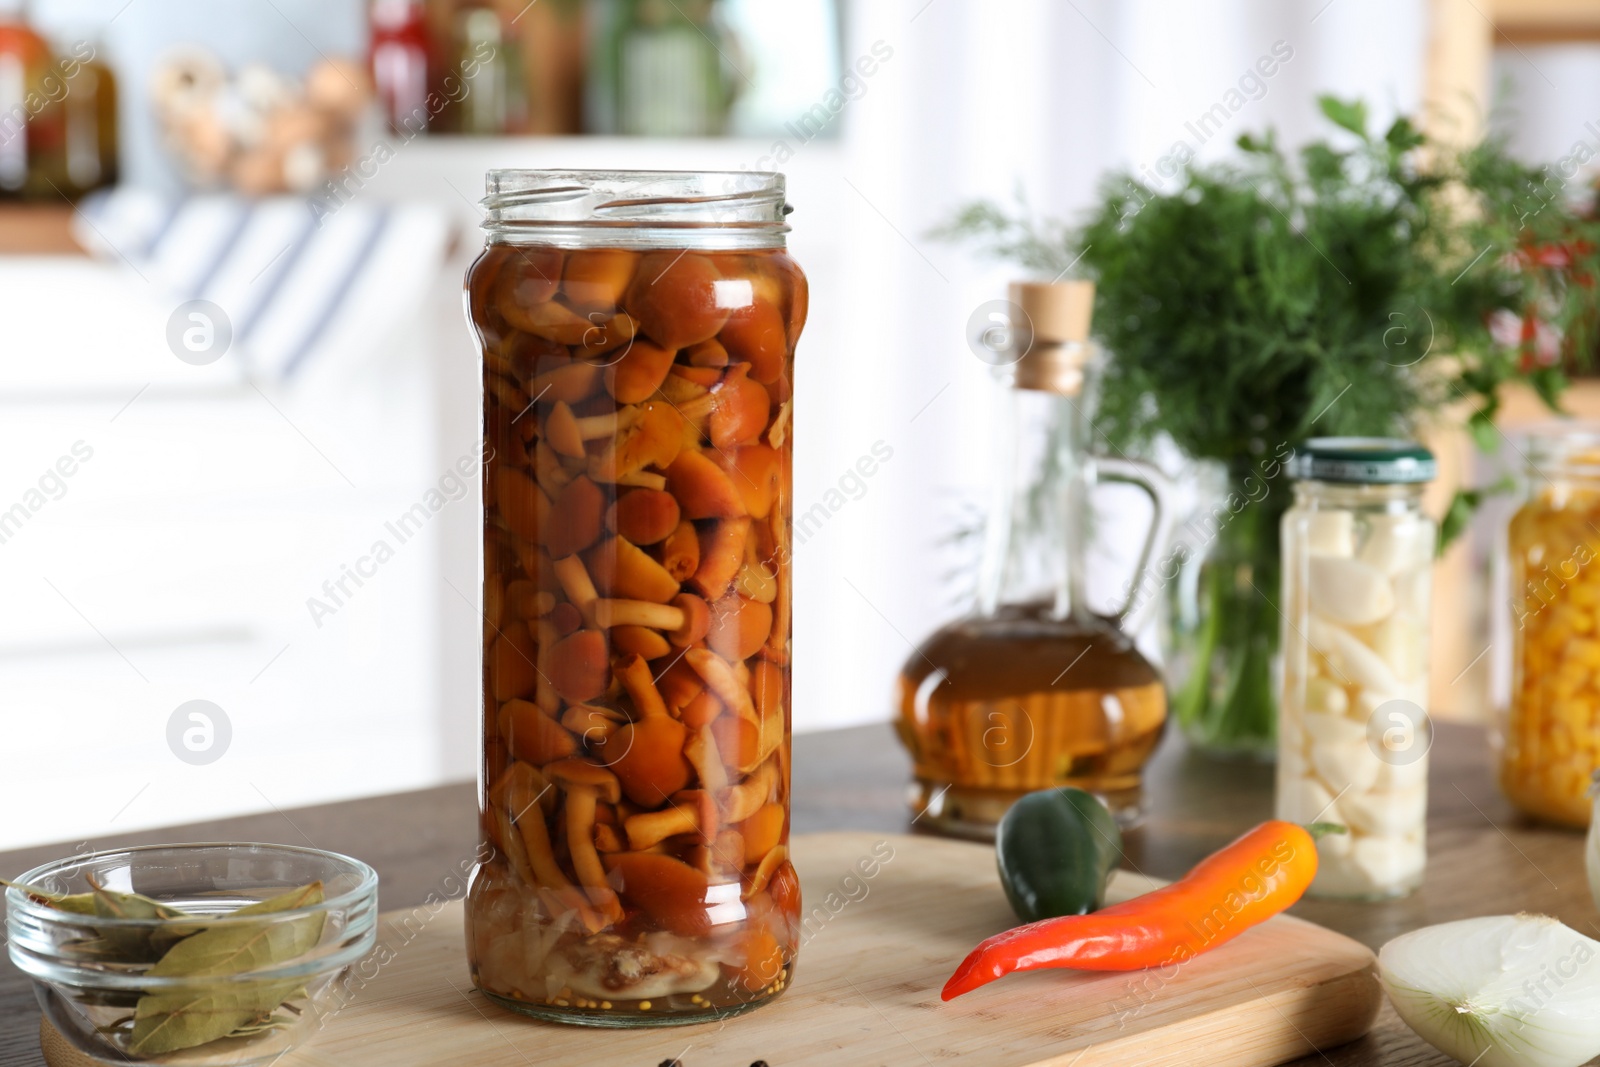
[{"x1": 74, "y1": 187, "x2": 453, "y2": 381}]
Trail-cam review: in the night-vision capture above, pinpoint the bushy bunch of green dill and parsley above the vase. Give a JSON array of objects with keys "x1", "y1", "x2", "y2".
[{"x1": 941, "y1": 98, "x2": 1600, "y2": 536}]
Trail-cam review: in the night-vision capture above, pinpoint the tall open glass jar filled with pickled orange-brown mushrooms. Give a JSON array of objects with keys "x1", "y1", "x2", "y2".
[{"x1": 467, "y1": 171, "x2": 806, "y2": 1027}]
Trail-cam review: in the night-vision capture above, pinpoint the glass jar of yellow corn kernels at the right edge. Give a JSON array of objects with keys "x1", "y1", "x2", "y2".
[{"x1": 1496, "y1": 424, "x2": 1600, "y2": 827}]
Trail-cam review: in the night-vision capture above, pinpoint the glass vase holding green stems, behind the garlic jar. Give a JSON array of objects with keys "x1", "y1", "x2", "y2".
[{"x1": 1165, "y1": 461, "x2": 1290, "y2": 761}]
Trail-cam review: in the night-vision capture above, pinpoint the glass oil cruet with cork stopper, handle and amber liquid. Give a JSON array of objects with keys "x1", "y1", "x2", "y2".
[{"x1": 898, "y1": 282, "x2": 1166, "y2": 838}]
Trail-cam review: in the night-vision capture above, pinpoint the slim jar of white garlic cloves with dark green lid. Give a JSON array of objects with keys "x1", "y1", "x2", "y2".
[{"x1": 1277, "y1": 437, "x2": 1437, "y2": 901}]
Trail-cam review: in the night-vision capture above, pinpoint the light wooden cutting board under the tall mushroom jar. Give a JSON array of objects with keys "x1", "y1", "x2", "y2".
[{"x1": 51, "y1": 833, "x2": 1381, "y2": 1067}]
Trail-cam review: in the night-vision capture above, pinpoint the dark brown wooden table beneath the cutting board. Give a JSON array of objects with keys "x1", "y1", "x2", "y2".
[{"x1": 0, "y1": 725, "x2": 1600, "y2": 1067}]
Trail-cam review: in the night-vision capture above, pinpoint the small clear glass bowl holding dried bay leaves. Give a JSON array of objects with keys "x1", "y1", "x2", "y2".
[{"x1": 5, "y1": 845, "x2": 378, "y2": 1067}]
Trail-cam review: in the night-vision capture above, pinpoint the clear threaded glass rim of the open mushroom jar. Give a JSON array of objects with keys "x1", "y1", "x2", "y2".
[{"x1": 480, "y1": 168, "x2": 794, "y2": 248}]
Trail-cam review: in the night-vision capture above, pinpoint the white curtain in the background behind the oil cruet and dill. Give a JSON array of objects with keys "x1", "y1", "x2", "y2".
[{"x1": 795, "y1": 0, "x2": 1427, "y2": 728}]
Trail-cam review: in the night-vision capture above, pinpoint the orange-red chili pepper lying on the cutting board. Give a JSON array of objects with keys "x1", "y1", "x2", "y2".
[{"x1": 941, "y1": 821, "x2": 1317, "y2": 1000}]
